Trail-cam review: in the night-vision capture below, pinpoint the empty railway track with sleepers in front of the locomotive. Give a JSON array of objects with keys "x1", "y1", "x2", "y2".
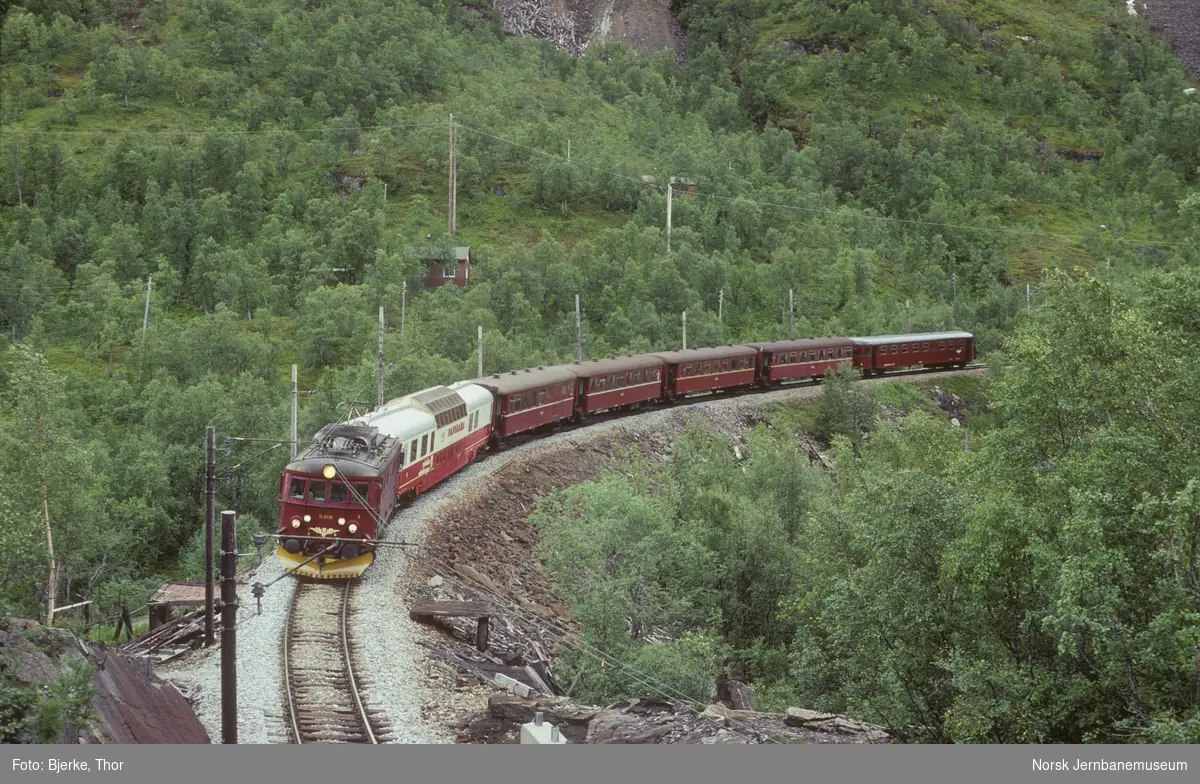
[{"x1": 283, "y1": 580, "x2": 390, "y2": 743}]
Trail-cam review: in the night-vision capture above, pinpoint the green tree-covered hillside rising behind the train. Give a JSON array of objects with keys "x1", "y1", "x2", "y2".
[{"x1": 0, "y1": 0, "x2": 1200, "y2": 715}]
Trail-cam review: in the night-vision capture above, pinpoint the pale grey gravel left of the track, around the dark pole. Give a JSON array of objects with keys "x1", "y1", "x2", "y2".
[{"x1": 157, "y1": 552, "x2": 295, "y2": 743}]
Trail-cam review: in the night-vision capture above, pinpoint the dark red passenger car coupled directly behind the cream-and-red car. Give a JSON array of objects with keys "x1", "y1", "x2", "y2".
[{"x1": 472, "y1": 365, "x2": 578, "y2": 445}]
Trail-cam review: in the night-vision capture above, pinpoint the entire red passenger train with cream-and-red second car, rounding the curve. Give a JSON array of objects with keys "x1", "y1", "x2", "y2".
[{"x1": 276, "y1": 331, "x2": 976, "y2": 580}]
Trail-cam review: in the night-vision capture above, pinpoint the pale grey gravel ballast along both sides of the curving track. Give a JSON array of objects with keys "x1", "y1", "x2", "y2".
[{"x1": 160, "y1": 369, "x2": 986, "y2": 743}]
